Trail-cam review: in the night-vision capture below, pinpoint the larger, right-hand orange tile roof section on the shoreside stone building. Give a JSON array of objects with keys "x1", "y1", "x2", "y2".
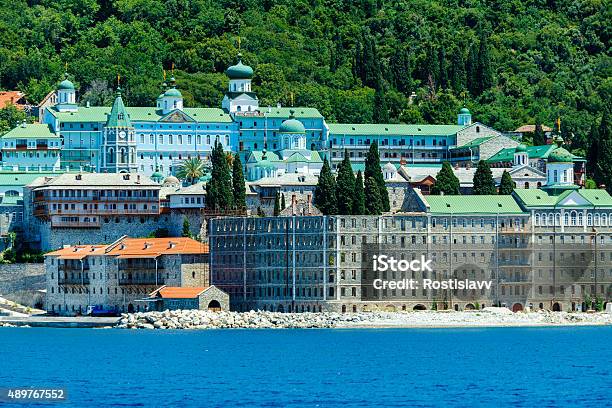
[{"x1": 108, "y1": 237, "x2": 208, "y2": 258}]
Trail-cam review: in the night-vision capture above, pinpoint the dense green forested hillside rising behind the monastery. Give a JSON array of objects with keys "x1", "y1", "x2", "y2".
[{"x1": 0, "y1": 0, "x2": 612, "y2": 155}]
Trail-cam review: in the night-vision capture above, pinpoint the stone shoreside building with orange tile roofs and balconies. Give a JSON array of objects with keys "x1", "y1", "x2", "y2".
[{"x1": 45, "y1": 237, "x2": 209, "y2": 315}]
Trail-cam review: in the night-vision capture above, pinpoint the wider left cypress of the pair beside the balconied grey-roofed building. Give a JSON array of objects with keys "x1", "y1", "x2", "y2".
[{"x1": 206, "y1": 142, "x2": 234, "y2": 212}]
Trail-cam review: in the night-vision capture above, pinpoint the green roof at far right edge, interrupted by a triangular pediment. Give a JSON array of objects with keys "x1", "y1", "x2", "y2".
[{"x1": 514, "y1": 186, "x2": 612, "y2": 208}]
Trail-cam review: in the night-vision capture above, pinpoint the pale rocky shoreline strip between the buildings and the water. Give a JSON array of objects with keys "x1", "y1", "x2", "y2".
[{"x1": 115, "y1": 307, "x2": 612, "y2": 329}]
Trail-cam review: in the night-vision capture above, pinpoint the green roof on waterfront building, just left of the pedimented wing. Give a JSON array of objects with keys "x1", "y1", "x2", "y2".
[{"x1": 425, "y1": 195, "x2": 525, "y2": 215}]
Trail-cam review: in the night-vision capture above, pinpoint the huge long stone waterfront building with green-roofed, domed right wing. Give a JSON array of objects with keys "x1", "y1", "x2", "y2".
[{"x1": 209, "y1": 153, "x2": 612, "y2": 311}]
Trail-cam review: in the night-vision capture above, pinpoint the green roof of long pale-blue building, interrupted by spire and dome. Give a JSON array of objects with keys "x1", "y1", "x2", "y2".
[{"x1": 49, "y1": 106, "x2": 232, "y2": 123}]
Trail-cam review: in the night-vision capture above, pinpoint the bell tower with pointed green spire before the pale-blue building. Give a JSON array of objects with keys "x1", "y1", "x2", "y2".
[{"x1": 101, "y1": 87, "x2": 137, "y2": 173}]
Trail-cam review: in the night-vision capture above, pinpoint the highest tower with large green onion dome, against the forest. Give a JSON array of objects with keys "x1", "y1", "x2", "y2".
[{"x1": 221, "y1": 53, "x2": 259, "y2": 113}]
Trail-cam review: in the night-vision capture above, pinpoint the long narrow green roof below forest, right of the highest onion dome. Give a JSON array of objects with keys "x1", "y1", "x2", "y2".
[{"x1": 328, "y1": 123, "x2": 466, "y2": 136}]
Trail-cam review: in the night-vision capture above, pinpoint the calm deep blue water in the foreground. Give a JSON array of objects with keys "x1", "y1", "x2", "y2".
[{"x1": 0, "y1": 327, "x2": 612, "y2": 408}]
